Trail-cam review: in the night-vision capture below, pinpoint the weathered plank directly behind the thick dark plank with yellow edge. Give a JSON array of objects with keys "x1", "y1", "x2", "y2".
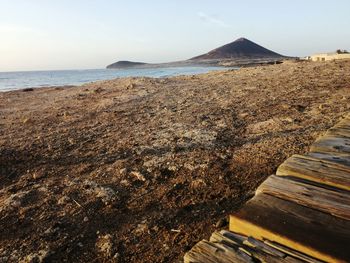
[{"x1": 256, "y1": 175, "x2": 350, "y2": 220}]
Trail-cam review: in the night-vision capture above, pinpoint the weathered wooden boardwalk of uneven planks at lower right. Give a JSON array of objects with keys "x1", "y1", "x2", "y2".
[{"x1": 184, "y1": 115, "x2": 350, "y2": 263}]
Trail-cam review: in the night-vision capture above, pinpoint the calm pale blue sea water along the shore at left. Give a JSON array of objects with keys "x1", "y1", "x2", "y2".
[{"x1": 0, "y1": 67, "x2": 224, "y2": 91}]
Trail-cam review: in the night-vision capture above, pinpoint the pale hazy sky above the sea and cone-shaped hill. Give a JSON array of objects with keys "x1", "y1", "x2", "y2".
[{"x1": 0, "y1": 0, "x2": 350, "y2": 71}]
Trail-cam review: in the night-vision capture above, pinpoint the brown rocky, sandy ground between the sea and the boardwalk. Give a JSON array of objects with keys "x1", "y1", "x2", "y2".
[{"x1": 0, "y1": 60, "x2": 350, "y2": 262}]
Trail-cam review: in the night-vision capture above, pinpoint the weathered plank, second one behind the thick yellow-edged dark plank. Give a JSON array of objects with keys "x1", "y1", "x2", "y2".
[{"x1": 276, "y1": 155, "x2": 350, "y2": 190}]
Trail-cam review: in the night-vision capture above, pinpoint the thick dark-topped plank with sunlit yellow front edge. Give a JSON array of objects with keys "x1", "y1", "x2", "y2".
[{"x1": 230, "y1": 194, "x2": 350, "y2": 262}]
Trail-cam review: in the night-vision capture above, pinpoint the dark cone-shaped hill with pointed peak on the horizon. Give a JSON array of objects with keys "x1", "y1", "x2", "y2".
[{"x1": 190, "y1": 38, "x2": 284, "y2": 60}]
